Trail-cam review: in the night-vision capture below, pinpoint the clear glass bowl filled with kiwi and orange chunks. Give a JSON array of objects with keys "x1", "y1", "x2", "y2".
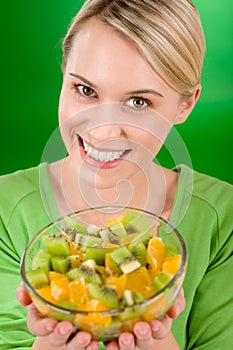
[{"x1": 21, "y1": 206, "x2": 187, "y2": 341}]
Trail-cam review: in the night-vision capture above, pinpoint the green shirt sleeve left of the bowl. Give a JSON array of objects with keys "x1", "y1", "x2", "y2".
[{"x1": 0, "y1": 218, "x2": 35, "y2": 350}]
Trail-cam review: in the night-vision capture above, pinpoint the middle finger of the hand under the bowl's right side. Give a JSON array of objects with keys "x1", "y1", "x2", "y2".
[{"x1": 134, "y1": 322, "x2": 154, "y2": 350}]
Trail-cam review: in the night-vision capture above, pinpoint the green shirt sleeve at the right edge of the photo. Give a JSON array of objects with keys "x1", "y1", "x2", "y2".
[{"x1": 186, "y1": 232, "x2": 233, "y2": 350}]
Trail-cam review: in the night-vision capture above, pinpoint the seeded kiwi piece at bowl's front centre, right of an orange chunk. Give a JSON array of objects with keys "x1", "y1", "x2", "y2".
[{"x1": 88, "y1": 283, "x2": 118, "y2": 309}]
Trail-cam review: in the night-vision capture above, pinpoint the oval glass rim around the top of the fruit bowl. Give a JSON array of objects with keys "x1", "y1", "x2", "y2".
[{"x1": 20, "y1": 205, "x2": 188, "y2": 316}]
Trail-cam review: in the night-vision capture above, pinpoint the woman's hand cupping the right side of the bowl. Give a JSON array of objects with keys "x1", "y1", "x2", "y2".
[{"x1": 106, "y1": 290, "x2": 185, "y2": 350}]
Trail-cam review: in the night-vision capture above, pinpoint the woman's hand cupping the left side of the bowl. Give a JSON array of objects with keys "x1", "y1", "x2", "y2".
[{"x1": 16, "y1": 283, "x2": 99, "y2": 350}]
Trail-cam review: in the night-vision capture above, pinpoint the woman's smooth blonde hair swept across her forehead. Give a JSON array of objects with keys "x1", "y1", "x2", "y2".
[{"x1": 63, "y1": 0, "x2": 205, "y2": 95}]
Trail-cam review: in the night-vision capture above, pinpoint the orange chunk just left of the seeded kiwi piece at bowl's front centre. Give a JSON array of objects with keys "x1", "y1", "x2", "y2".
[{"x1": 68, "y1": 277, "x2": 90, "y2": 308}]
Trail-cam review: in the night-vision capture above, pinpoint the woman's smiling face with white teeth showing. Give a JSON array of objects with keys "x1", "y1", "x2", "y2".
[{"x1": 59, "y1": 18, "x2": 197, "y2": 187}]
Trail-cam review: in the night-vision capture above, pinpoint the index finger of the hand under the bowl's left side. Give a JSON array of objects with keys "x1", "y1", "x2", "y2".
[{"x1": 27, "y1": 304, "x2": 57, "y2": 336}]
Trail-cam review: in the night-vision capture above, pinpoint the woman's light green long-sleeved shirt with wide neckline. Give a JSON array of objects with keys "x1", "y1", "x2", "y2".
[{"x1": 0, "y1": 164, "x2": 233, "y2": 350}]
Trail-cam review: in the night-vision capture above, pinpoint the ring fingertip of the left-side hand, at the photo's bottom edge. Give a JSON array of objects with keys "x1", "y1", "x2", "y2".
[{"x1": 66, "y1": 331, "x2": 92, "y2": 350}]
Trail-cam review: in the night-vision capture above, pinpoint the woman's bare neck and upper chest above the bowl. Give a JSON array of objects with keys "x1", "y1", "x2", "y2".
[{"x1": 49, "y1": 158, "x2": 178, "y2": 219}]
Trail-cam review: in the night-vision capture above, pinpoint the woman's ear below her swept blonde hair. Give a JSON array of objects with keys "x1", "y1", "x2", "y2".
[{"x1": 174, "y1": 84, "x2": 201, "y2": 124}]
